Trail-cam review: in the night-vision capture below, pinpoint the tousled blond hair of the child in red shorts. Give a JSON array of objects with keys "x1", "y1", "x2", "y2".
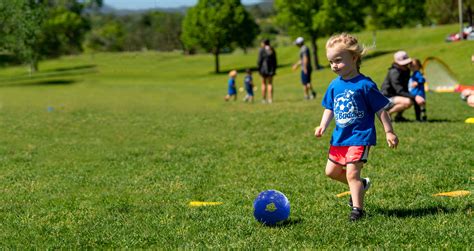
[{"x1": 326, "y1": 32, "x2": 369, "y2": 71}]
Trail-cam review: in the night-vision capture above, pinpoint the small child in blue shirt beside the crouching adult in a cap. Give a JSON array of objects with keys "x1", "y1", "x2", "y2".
[{"x1": 408, "y1": 59, "x2": 428, "y2": 121}]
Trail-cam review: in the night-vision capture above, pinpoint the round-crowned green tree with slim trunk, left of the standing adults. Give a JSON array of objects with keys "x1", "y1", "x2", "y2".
[{"x1": 181, "y1": 0, "x2": 256, "y2": 73}]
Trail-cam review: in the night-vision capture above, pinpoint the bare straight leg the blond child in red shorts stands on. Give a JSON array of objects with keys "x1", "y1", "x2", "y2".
[{"x1": 346, "y1": 162, "x2": 364, "y2": 209}]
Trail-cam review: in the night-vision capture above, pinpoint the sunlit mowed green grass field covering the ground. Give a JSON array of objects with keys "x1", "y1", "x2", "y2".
[{"x1": 0, "y1": 26, "x2": 474, "y2": 250}]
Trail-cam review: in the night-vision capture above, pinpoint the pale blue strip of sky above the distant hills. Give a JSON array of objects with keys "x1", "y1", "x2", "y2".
[{"x1": 104, "y1": 0, "x2": 262, "y2": 10}]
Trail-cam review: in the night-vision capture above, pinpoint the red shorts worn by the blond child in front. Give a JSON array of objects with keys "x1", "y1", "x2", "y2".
[{"x1": 328, "y1": 146, "x2": 370, "y2": 166}]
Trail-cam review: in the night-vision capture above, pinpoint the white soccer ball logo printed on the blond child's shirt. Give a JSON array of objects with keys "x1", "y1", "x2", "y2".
[{"x1": 334, "y1": 90, "x2": 364, "y2": 127}]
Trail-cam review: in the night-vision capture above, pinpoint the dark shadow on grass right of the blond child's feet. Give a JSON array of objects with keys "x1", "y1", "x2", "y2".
[{"x1": 375, "y1": 204, "x2": 473, "y2": 218}]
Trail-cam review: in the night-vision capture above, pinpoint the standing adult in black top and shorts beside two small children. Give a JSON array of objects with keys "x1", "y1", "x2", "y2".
[{"x1": 257, "y1": 39, "x2": 277, "y2": 104}]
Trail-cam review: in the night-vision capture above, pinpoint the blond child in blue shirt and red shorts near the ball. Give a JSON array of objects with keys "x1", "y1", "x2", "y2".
[{"x1": 314, "y1": 33, "x2": 398, "y2": 221}]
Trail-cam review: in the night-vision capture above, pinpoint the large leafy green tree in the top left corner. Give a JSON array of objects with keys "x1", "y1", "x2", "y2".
[{"x1": 0, "y1": 0, "x2": 102, "y2": 72}]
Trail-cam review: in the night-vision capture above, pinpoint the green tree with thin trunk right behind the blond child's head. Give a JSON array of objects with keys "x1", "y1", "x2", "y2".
[{"x1": 275, "y1": 0, "x2": 365, "y2": 69}]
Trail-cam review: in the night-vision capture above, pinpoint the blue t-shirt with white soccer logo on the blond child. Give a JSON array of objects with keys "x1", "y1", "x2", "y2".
[{"x1": 322, "y1": 74, "x2": 390, "y2": 146}]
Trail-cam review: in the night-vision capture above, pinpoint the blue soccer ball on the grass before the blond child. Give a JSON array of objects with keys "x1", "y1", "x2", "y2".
[{"x1": 253, "y1": 190, "x2": 290, "y2": 226}]
